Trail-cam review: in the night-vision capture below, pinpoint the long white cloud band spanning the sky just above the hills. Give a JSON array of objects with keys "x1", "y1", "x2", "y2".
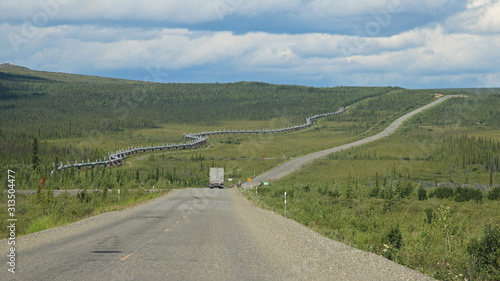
[{"x1": 0, "y1": 22, "x2": 500, "y2": 82}]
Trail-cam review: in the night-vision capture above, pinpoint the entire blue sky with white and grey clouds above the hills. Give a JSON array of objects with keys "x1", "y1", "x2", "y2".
[{"x1": 0, "y1": 0, "x2": 500, "y2": 88}]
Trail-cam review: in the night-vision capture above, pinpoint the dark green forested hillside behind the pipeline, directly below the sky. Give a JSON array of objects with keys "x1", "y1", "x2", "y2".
[{"x1": 0, "y1": 64, "x2": 402, "y2": 140}]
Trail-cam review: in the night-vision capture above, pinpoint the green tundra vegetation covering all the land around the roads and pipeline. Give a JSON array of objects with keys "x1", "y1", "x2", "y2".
[{"x1": 0, "y1": 65, "x2": 500, "y2": 280}]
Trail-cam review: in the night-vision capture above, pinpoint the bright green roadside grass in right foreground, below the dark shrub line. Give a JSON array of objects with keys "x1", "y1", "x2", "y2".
[{"x1": 243, "y1": 180, "x2": 500, "y2": 280}]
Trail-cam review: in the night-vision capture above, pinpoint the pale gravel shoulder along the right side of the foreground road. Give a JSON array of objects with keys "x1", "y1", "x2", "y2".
[{"x1": 229, "y1": 190, "x2": 434, "y2": 280}]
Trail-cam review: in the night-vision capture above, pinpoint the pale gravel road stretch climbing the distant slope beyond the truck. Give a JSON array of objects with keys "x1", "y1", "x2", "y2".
[{"x1": 241, "y1": 95, "x2": 459, "y2": 188}]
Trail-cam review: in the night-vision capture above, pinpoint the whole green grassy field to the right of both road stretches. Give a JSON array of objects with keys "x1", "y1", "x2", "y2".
[{"x1": 242, "y1": 94, "x2": 500, "y2": 280}]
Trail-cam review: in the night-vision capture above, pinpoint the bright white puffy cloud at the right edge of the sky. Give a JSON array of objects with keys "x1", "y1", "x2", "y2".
[{"x1": 349, "y1": 27, "x2": 500, "y2": 75}]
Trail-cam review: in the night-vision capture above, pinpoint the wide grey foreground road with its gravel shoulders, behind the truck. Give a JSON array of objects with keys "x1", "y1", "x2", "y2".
[{"x1": 0, "y1": 189, "x2": 431, "y2": 281}]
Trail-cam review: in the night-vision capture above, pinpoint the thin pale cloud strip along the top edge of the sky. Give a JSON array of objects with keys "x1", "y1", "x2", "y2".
[{"x1": 0, "y1": 0, "x2": 462, "y2": 26}]
